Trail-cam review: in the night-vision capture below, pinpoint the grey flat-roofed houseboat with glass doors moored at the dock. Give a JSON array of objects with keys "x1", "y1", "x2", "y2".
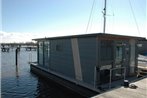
[{"x1": 30, "y1": 33, "x2": 143, "y2": 94}]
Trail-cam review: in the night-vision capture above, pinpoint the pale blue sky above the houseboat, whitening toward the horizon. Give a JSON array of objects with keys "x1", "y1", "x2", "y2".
[{"x1": 0, "y1": 0, "x2": 147, "y2": 42}]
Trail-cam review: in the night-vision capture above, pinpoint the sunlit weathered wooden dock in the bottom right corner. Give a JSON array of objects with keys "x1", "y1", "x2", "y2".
[{"x1": 92, "y1": 76, "x2": 147, "y2": 98}]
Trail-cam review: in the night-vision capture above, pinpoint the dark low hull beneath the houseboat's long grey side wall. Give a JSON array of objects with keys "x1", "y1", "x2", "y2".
[{"x1": 30, "y1": 63, "x2": 100, "y2": 97}]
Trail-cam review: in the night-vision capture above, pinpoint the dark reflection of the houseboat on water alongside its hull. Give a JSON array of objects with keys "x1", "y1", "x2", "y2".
[{"x1": 36, "y1": 78, "x2": 84, "y2": 98}]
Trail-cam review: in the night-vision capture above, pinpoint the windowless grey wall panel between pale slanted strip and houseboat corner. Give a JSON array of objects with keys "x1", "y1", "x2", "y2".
[{"x1": 78, "y1": 37, "x2": 96, "y2": 85}]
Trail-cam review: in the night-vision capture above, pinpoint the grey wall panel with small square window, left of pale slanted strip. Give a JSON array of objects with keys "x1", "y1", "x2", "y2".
[{"x1": 49, "y1": 39, "x2": 75, "y2": 78}]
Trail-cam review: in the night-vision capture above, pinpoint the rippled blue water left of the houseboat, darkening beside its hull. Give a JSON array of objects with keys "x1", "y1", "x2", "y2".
[{"x1": 1, "y1": 49, "x2": 83, "y2": 98}]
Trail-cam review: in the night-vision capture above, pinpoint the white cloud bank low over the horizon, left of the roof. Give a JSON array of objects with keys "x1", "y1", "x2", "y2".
[{"x1": 0, "y1": 31, "x2": 81, "y2": 43}]
